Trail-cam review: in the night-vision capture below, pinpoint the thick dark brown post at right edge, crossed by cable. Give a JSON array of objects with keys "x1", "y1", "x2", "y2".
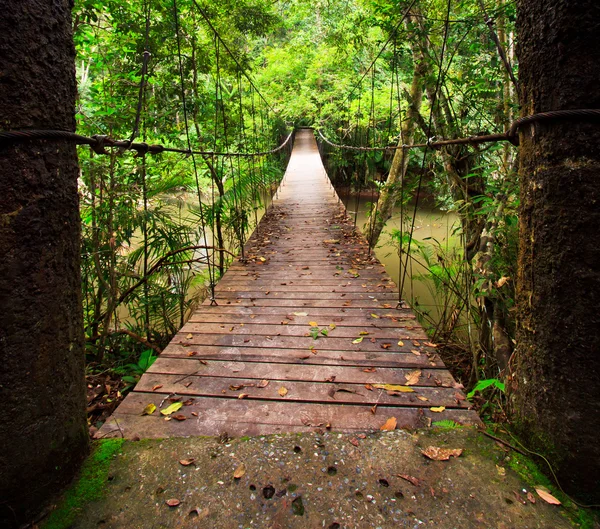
[{"x1": 510, "y1": 0, "x2": 600, "y2": 503}]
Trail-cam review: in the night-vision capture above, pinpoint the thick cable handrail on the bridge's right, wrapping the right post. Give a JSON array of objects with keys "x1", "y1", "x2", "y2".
[{"x1": 314, "y1": 108, "x2": 600, "y2": 152}]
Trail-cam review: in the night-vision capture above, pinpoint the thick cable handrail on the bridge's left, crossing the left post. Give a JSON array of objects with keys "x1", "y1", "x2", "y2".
[{"x1": 0, "y1": 130, "x2": 294, "y2": 158}]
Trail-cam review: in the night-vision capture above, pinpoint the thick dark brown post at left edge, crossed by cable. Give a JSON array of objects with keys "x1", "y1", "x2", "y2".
[{"x1": 0, "y1": 0, "x2": 88, "y2": 527}]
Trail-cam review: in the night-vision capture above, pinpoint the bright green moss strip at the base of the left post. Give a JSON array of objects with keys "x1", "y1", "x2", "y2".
[{"x1": 41, "y1": 439, "x2": 124, "y2": 529}]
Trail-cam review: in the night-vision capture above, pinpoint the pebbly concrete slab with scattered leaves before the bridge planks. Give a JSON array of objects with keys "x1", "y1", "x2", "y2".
[{"x1": 52, "y1": 428, "x2": 592, "y2": 529}]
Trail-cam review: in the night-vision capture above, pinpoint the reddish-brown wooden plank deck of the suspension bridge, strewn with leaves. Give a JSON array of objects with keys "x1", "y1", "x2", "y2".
[{"x1": 97, "y1": 130, "x2": 479, "y2": 438}]
